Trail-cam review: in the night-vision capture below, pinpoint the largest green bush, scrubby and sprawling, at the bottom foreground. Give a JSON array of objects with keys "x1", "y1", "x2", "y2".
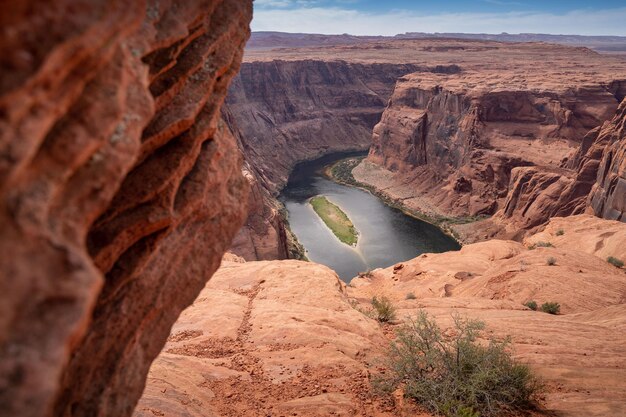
[{"x1": 377, "y1": 312, "x2": 541, "y2": 417}]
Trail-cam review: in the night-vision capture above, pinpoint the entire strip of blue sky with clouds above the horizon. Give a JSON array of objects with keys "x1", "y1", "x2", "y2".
[{"x1": 252, "y1": 0, "x2": 626, "y2": 36}]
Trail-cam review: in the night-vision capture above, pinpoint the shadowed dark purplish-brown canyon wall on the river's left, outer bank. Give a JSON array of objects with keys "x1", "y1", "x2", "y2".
[{"x1": 224, "y1": 59, "x2": 446, "y2": 260}]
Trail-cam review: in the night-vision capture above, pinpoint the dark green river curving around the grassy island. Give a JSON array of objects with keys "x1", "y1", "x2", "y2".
[{"x1": 280, "y1": 153, "x2": 459, "y2": 282}]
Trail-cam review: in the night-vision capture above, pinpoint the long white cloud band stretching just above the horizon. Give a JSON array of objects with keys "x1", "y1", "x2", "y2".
[{"x1": 252, "y1": 5, "x2": 626, "y2": 36}]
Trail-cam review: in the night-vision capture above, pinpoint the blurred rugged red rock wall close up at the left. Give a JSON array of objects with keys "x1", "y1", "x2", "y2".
[{"x1": 0, "y1": 0, "x2": 252, "y2": 417}]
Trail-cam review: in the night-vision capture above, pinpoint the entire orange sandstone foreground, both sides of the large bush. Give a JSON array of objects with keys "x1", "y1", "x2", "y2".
[{"x1": 135, "y1": 215, "x2": 626, "y2": 417}]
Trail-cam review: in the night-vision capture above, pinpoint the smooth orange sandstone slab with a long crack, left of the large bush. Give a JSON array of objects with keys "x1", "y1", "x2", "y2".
[{"x1": 135, "y1": 261, "x2": 395, "y2": 417}]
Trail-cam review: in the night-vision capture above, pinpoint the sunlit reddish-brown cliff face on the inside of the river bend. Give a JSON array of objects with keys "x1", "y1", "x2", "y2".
[{"x1": 368, "y1": 73, "x2": 617, "y2": 220}]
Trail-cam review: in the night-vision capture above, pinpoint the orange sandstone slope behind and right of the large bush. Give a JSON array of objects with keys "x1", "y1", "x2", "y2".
[{"x1": 348, "y1": 215, "x2": 626, "y2": 416}]
